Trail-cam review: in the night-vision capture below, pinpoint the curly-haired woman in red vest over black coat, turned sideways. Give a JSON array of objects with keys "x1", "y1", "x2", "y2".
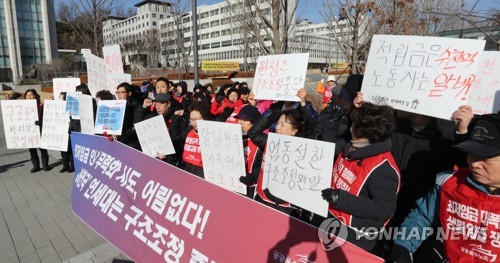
[{"x1": 322, "y1": 102, "x2": 400, "y2": 251}]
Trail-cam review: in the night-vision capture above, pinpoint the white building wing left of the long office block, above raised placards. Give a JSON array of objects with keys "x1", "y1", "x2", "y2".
[{"x1": 103, "y1": 0, "x2": 171, "y2": 68}]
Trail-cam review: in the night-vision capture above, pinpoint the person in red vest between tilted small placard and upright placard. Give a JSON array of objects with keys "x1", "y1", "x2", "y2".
[{"x1": 169, "y1": 101, "x2": 211, "y2": 178}]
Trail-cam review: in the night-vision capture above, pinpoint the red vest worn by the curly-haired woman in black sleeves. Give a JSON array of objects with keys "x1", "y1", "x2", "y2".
[{"x1": 328, "y1": 152, "x2": 401, "y2": 227}]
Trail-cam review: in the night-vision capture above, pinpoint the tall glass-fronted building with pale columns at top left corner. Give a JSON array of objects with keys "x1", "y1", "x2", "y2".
[{"x1": 0, "y1": 0, "x2": 57, "y2": 83}]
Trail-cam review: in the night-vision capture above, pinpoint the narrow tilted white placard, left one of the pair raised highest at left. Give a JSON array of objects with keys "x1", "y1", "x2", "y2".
[{"x1": 84, "y1": 53, "x2": 108, "y2": 97}]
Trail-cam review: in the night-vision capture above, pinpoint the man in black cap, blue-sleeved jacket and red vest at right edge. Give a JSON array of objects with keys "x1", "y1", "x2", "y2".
[{"x1": 387, "y1": 114, "x2": 500, "y2": 263}]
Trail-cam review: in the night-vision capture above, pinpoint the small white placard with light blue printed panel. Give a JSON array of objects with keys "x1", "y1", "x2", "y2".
[{"x1": 94, "y1": 100, "x2": 127, "y2": 135}]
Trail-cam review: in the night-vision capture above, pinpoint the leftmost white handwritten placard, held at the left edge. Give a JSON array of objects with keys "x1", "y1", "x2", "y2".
[{"x1": 1, "y1": 100, "x2": 40, "y2": 149}]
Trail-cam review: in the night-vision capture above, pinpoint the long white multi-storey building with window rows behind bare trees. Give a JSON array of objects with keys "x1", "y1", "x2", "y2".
[{"x1": 160, "y1": 0, "x2": 345, "y2": 68}]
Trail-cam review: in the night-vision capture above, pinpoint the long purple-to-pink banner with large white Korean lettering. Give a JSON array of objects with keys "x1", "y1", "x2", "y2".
[{"x1": 71, "y1": 133, "x2": 383, "y2": 263}]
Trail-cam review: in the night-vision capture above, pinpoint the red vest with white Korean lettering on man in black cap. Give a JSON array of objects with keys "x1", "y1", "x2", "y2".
[{"x1": 439, "y1": 169, "x2": 500, "y2": 262}]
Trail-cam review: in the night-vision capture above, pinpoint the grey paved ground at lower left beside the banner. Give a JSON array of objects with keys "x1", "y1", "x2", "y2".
[{"x1": 0, "y1": 103, "x2": 133, "y2": 263}]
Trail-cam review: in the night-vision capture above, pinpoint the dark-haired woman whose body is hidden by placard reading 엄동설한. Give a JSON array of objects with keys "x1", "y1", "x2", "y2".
[{"x1": 244, "y1": 88, "x2": 314, "y2": 217}]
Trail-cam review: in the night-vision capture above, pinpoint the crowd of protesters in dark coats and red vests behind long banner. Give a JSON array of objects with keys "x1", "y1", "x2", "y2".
[{"x1": 5, "y1": 72, "x2": 500, "y2": 262}]
